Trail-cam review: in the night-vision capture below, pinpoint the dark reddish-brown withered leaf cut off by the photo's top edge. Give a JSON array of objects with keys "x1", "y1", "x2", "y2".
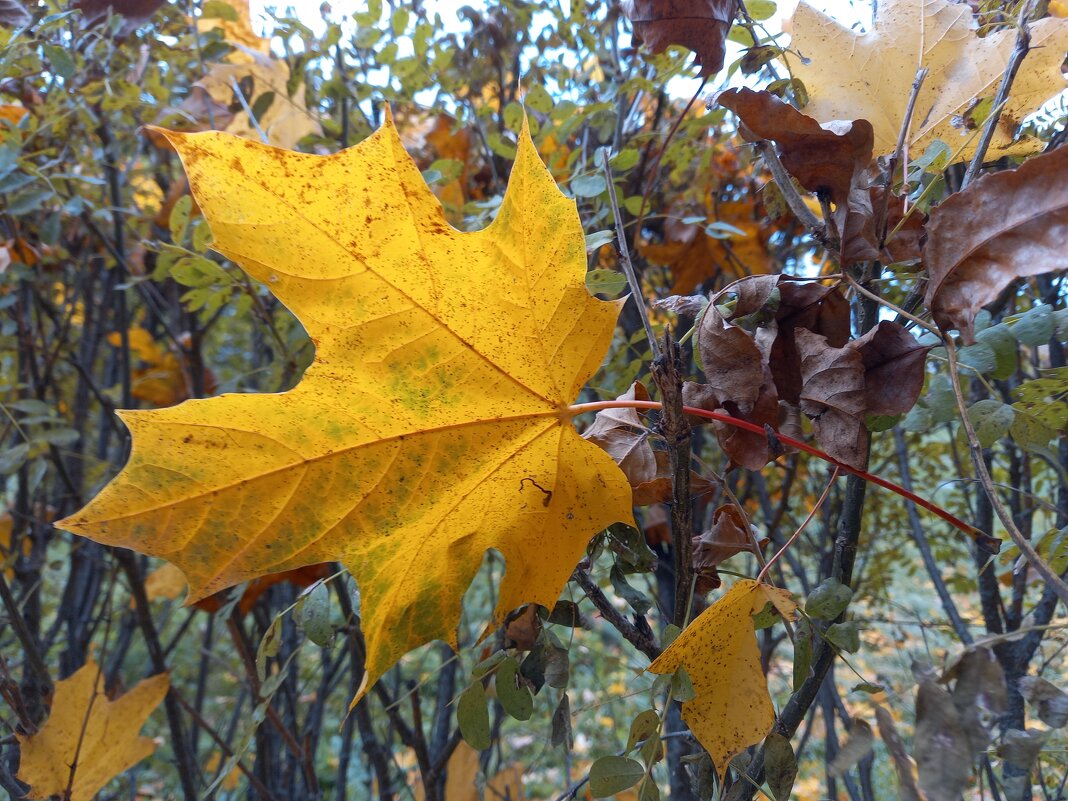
[{"x1": 623, "y1": 0, "x2": 736, "y2": 76}]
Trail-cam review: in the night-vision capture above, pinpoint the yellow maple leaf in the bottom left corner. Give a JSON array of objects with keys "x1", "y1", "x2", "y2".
[{"x1": 15, "y1": 659, "x2": 171, "y2": 801}]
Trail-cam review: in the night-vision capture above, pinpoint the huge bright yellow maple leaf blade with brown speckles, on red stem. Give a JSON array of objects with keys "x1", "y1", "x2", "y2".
[{"x1": 60, "y1": 111, "x2": 632, "y2": 700}]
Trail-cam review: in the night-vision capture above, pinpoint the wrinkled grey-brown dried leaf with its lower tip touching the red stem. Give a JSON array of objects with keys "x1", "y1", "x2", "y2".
[{"x1": 796, "y1": 328, "x2": 868, "y2": 470}]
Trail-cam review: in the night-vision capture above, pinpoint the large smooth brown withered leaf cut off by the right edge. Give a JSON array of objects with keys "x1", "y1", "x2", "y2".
[{"x1": 924, "y1": 146, "x2": 1068, "y2": 343}]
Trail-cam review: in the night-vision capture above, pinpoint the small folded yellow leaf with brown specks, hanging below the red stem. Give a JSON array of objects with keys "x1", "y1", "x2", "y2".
[{"x1": 648, "y1": 579, "x2": 797, "y2": 778}]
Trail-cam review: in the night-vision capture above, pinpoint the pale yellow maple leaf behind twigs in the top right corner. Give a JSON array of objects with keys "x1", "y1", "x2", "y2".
[{"x1": 784, "y1": 0, "x2": 1068, "y2": 159}]
